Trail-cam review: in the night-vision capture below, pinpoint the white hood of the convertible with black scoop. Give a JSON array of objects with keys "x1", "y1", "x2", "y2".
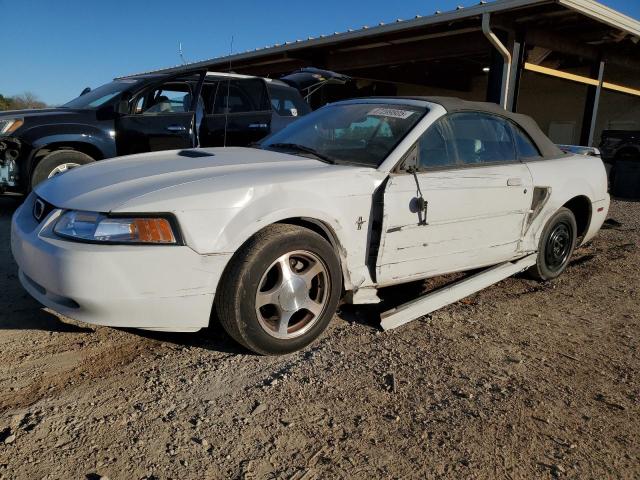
[{"x1": 35, "y1": 147, "x2": 372, "y2": 212}]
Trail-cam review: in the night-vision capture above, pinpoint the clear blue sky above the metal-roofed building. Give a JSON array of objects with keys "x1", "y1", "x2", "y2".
[{"x1": 0, "y1": 0, "x2": 640, "y2": 104}]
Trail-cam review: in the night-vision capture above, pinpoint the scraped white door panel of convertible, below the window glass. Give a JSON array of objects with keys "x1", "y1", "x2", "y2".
[{"x1": 377, "y1": 164, "x2": 533, "y2": 284}]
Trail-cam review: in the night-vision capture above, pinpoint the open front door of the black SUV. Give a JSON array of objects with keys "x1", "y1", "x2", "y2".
[{"x1": 116, "y1": 75, "x2": 202, "y2": 155}]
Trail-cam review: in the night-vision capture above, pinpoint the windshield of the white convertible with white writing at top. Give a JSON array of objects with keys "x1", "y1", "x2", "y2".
[{"x1": 260, "y1": 103, "x2": 427, "y2": 168}]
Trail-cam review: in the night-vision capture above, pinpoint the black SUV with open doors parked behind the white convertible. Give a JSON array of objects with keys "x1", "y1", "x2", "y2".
[{"x1": 0, "y1": 68, "x2": 349, "y2": 192}]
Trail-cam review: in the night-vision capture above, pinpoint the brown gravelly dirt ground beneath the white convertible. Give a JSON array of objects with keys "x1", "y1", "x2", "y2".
[{"x1": 0, "y1": 198, "x2": 640, "y2": 480}]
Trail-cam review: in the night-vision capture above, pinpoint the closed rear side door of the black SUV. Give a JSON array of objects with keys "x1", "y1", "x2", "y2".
[{"x1": 201, "y1": 78, "x2": 272, "y2": 147}]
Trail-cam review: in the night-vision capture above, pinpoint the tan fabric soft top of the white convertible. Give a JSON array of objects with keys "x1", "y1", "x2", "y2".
[{"x1": 402, "y1": 97, "x2": 566, "y2": 158}]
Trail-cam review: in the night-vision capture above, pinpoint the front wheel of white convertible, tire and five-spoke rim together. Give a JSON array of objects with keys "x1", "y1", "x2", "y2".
[{"x1": 214, "y1": 224, "x2": 342, "y2": 355}]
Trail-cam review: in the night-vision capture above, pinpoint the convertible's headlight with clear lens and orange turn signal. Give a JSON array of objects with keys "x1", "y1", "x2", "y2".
[{"x1": 53, "y1": 210, "x2": 178, "y2": 244}]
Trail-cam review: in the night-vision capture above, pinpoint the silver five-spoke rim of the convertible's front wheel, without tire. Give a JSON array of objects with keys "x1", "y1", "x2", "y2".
[{"x1": 255, "y1": 250, "x2": 330, "y2": 339}]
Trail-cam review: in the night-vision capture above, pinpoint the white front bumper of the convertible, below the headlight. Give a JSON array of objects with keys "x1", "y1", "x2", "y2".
[{"x1": 11, "y1": 195, "x2": 231, "y2": 332}]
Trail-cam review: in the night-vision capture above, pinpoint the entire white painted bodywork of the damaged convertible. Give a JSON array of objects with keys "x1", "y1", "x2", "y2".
[{"x1": 12, "y1": 100, "x2": 609, "y2": 331}]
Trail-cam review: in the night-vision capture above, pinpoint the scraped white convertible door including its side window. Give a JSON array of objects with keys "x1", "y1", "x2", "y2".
[{"x1": 376, "y1": 112, "x2": 532, "y2": 284}]
